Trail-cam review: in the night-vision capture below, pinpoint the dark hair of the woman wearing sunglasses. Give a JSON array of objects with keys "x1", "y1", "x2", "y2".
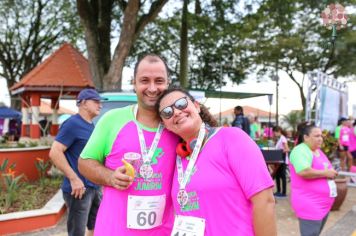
[{"x1": 156, "y1": 87, "x2": 218, "y2": 127}]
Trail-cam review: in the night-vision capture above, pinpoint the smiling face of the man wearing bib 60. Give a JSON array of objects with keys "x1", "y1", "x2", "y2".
[{"x1": 134, "y1": 59, "x2": 169, "y2": 110}]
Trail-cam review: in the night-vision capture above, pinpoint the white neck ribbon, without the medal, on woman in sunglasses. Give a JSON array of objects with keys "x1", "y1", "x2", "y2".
[{"x1": 176, "y1": 123, "x2": 205, "y2": 190}]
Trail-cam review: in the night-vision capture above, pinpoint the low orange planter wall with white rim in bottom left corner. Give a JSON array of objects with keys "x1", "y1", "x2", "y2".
[{"x1": 0, "y1": 190, "x2": 66, "y2": 235}]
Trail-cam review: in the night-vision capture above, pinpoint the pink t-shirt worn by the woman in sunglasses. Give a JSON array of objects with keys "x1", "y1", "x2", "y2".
[{"x1": 172, "y1": 127, "x2": 273, "y2": 236}]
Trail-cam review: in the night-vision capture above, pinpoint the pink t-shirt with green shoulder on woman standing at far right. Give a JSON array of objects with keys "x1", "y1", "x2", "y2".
[{"x1": 289, "y1": 145, "x2": 334, "y2": 220}]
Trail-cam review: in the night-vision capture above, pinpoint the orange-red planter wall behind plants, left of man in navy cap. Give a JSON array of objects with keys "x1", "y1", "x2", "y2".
[{"x1": 0, "y1": 146, "x2": 50, "y2": 181}]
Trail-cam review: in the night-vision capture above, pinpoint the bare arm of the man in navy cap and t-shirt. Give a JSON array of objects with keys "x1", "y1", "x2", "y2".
[{"x1": 49, "y1": 141, "x2": 85, "y2": 199}]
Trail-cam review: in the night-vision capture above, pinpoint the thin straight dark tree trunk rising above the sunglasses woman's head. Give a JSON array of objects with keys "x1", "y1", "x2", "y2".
[{"x1": 179, "y1": 0, "x2": 189, "y2": 88}]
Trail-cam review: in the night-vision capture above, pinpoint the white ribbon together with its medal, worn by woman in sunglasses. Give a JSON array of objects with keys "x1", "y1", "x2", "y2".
[{"x1": 176, "y1": 123, "x2": 206, "y2": 207}]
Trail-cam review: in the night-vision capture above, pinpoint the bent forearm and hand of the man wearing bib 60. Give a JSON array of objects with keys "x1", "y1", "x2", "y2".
[{"x1": 78, "y1": 158, "x2": 133, "y2": 190}]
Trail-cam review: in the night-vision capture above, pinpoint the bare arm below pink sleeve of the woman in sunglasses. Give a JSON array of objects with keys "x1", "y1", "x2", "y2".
[{"x1": 251, "y1": 188, "x2": 277, "y2": 236}]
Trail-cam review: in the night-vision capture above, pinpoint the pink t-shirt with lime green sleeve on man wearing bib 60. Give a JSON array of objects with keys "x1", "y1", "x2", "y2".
[{"x1": 81, "y1": 107, "x2": 179, "y2": 236}]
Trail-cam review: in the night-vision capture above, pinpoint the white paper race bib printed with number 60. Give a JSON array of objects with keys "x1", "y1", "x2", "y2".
[{"x1": 127, "y1": 194, "x2": 166, "y2": 229}]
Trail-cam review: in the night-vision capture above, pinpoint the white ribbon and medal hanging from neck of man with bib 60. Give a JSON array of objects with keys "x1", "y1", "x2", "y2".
[{"x1": 134, "y1": 105, "x2": 163, "y2": 179}]
